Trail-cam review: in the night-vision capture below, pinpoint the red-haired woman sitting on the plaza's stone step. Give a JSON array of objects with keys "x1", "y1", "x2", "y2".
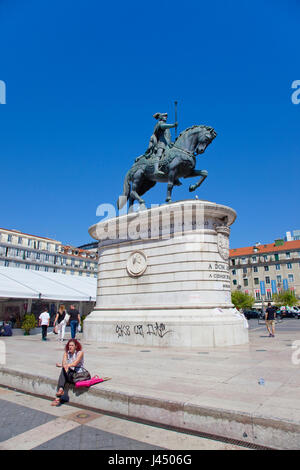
[{"x1": 51, "y1": 339, "x2": 90, "y2": 406}]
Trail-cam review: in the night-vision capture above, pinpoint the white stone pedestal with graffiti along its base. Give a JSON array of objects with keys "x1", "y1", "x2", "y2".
[{"x1": 84, "y1": 200, "x2": 248, "y2": 348}]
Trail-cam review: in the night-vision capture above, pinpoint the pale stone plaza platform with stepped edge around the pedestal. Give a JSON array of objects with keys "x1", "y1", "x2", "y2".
[{"x1": 0, "y1": 320, "x2": 300, "y2": 449}]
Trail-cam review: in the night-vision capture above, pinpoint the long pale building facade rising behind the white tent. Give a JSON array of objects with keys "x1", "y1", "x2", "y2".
[{"x1": 0, "y1": 228, "x2": 97, "y2": 277}]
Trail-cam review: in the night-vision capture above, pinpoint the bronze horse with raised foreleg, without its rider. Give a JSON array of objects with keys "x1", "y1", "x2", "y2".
[{"x1": 117, "y1": 126, "x2": 217, "y2": 210}]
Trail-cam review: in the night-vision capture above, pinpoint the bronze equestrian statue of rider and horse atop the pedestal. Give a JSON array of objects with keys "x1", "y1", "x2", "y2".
[{"x1": 117, "y1": 113, "x2": 217, "y2": 211}]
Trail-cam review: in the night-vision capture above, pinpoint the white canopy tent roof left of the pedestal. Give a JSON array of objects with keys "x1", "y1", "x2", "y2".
[{"x1": 0, "y1": 266, "x2": 97, "y2": 302}]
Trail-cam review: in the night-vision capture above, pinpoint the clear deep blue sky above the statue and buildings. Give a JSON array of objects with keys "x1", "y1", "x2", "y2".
[{"x1": 0, "y1": 0, "x2": 300, "y2": 247}]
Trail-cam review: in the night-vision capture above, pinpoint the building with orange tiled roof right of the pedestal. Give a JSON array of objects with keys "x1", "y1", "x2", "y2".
[{"x1": 229, "y1": 239, "x2": 300, "y2": 307}]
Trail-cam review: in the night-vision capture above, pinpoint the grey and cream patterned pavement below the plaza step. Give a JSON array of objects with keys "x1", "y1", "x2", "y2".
[{"x1": 0, "y1": 388, "x2": 241, "y2": 451}]
